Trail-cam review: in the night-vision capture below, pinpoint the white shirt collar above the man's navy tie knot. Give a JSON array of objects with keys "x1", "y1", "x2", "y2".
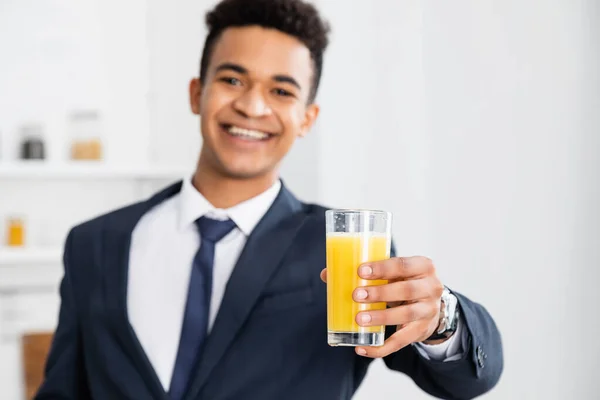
[{"x1": 178, "y1": 174, "x2": 281, "y2": 236}]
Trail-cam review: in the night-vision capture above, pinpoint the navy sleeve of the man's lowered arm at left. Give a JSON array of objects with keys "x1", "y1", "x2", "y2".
[{"x1": 34, "y1": 231, "x2": 91, "y2": 400}]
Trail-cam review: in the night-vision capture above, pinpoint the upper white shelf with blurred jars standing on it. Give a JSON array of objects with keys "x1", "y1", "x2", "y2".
[{"x1": 0, "y1": 161, "x2": 186, "y2": 180}]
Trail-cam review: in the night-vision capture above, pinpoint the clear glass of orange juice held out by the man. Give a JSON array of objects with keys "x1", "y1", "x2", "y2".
[{"x1": 325, "y1": 209, "x2": 392, "y2": 346}]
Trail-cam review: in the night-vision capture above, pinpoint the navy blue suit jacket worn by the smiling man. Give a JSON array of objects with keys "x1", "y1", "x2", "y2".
[{"x1": 35, "y1": 183, "x2": 503, "y2": 400}]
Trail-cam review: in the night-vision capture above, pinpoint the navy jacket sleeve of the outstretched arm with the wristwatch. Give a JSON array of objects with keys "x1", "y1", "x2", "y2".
[{"x1": 384, "y1": 291, "x2": 503, "y2": 400}]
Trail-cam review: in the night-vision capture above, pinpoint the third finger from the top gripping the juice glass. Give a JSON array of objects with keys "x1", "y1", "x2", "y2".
[{"x1": 356, "y1": 301, "x2": 439, "y2": 326}]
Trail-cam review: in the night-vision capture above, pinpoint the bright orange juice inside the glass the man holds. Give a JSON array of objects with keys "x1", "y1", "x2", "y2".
[{"x1": 327, "y1": 233, "x2": 390, "y2": 333}]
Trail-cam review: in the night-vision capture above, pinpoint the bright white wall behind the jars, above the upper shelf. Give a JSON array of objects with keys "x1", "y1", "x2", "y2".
[{"x1": 0, "y1": 0, "x2": 149, "y2": 164}]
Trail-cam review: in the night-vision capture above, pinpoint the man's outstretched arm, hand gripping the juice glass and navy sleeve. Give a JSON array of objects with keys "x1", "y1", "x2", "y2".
[{"x1": 321, "y1": 239, "x2": 503, "y2": 400}]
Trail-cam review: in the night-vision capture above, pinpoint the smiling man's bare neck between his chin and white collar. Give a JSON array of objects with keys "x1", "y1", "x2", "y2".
[{"x1": 192, "y1": 163, "x2": 278, "y2": 209}]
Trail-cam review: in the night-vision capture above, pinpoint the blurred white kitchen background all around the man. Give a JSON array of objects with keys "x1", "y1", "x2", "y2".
[{"x1": 0, "y1": 0, "x2": 600, "y2": 400}]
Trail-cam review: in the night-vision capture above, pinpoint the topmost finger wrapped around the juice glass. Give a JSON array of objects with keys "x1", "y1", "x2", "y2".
[{"x1": 358, "y1": 256, "x2": 434, "y2": 280}]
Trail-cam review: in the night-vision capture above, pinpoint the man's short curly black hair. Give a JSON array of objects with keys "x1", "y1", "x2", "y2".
[{"x1": 200, "y1": 0, "x2": 329, "y2": 102}]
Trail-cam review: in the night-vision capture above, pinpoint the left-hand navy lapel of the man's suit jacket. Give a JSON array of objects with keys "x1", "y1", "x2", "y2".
[{"x1": 102, "y1": 182, "x2": 181, "y2": 399}]
